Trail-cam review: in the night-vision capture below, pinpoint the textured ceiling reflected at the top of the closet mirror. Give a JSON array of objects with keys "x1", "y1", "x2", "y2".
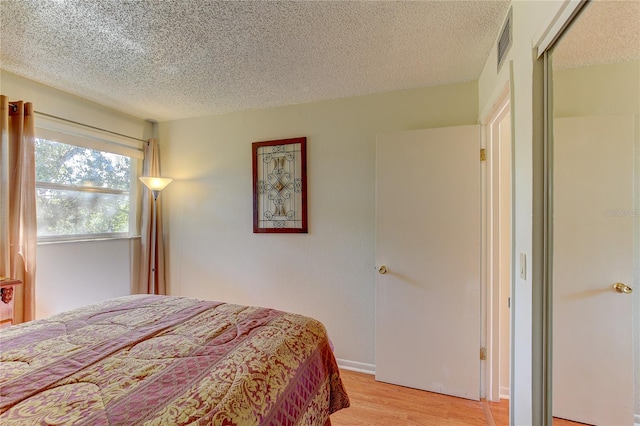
[{"x1": 553, "y1": 0, "x2": 640, "y2": 70}]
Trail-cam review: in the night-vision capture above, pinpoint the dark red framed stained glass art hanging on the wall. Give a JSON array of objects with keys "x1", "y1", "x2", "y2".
[{"x1": 252, "y1": 137, "x2": 307, "y2": 234}]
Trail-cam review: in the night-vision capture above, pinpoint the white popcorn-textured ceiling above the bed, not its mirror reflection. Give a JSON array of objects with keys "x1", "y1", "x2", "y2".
[{"x1": 0, "y1": 0, "x2": 509, "y2": 121}]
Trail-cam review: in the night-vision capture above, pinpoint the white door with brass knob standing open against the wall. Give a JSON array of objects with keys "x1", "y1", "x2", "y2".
[{"x1": 375, "y1": 126, "x2": 481, "y2": 400}]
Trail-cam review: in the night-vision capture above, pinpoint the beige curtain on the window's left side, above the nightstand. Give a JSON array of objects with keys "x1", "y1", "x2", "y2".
[{"x1": 0, "y1": 95, "x2": 37, "y2": 322}]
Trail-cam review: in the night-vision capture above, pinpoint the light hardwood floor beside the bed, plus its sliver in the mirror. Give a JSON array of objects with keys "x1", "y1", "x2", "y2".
[{"x1": 331, "y1": 370, "x2": 579, "y2": 426}]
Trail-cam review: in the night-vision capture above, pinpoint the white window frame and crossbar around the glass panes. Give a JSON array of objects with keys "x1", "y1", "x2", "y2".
[{"x1": 35, "y1": 115, "x2": 144, "y2": 243}]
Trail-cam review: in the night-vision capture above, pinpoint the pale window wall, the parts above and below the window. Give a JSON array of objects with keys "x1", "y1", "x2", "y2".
[{"x1": 0, "y1": 71, "x2": 153, "y2": 318}]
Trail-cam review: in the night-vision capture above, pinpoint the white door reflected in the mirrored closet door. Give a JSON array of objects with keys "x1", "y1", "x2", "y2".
[{"x1": 552, "y1": 116, "x2": 640, "y2": 425}]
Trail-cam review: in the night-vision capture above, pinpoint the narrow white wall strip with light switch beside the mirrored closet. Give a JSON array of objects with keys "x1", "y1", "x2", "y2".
[{"x1": 478, "y1": 0, "x2": 564, "y2": 425}]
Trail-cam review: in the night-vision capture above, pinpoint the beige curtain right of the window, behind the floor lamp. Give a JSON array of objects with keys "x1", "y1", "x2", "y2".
[{"x1": 138, "y1": 139, "x2": 167, "y2": 294}]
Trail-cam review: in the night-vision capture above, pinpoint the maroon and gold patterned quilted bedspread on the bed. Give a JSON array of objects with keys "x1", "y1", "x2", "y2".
[{"x1": 0, "y1": 295, "x2": 349, "y2": 426}]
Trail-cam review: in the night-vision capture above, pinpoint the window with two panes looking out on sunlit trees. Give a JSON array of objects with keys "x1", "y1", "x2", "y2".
[{"x1": 35, "y1": 118, "x2": 141, "y2": 241}]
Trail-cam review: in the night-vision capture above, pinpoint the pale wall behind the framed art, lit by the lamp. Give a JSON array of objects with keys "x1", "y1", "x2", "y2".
[{"x1": 159, "y1": 82, "x2": 478, "y2": 366}]
